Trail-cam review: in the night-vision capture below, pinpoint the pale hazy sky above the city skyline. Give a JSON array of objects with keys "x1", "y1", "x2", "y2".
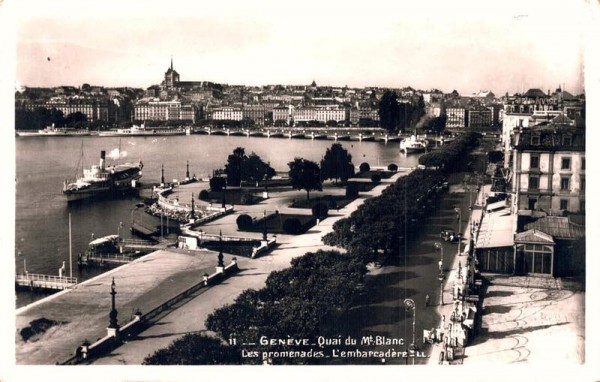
[{"x1": 9, "y1": 0, "x2": 590, "y2": 95}]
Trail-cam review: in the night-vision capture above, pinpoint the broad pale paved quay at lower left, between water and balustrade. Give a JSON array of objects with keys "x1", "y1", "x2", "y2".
[{"x1": 15, "y1": 250, "x2": 231, "y2": 365}]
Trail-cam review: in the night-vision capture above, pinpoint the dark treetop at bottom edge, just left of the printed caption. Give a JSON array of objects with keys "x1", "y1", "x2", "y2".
[{"x1": 143, "y1": 334, "x2": 242, "y2": 365}]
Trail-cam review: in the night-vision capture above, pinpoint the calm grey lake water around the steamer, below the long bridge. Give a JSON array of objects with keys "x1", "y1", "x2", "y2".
[{"x1": 15, "y1": 135, "x2": 418, "y2": 306}]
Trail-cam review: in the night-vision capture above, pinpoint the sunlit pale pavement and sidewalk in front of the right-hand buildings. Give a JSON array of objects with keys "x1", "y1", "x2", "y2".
[{"x1": 429, "y1": 185, "x2": 585, "y2": 366}]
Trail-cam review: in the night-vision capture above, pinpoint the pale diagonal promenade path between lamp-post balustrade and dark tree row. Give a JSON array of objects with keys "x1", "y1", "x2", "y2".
[{"x1": 93, "y1": 172, "x2": 406, "y2": 365}]
